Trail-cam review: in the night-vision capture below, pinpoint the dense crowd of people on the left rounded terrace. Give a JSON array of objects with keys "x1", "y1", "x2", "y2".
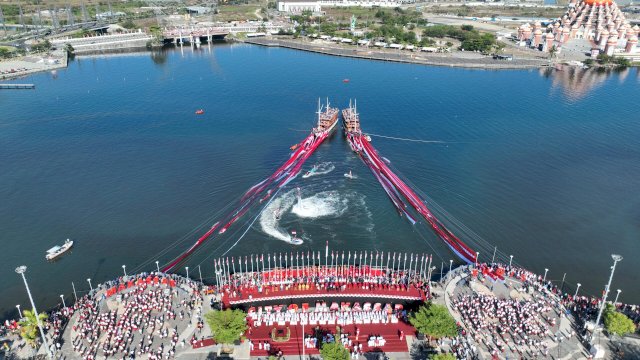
[{"x1": 71, "y1": 275, "x2": 202, "y2": 360}]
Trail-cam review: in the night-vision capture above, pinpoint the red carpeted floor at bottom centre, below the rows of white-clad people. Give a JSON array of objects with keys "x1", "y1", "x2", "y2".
[{"x1": 246, "y1": 322, "x2": 415, "y2": 356}]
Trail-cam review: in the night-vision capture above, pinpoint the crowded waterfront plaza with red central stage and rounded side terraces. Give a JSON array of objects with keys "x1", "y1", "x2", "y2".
[{"x1": 2, "y1": 256, "x2": 640, "y2": 360}]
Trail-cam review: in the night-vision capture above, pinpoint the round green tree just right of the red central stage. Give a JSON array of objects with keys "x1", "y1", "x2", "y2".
[{"x1": 409, "y1": 302, "x2": 458, "y2": 338}]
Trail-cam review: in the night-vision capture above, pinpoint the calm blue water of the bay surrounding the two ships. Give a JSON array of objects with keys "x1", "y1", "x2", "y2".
[{"x1": 0, "y1": 45, "x2": 640, "y2": 315}]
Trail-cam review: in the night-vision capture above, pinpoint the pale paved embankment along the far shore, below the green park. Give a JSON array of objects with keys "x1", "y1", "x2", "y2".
[{"x1": 242, "y1": 38, "x2": 551, "y2": 70}]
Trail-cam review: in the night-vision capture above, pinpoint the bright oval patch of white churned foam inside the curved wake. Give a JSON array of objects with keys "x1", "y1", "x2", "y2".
[{"x1": 291, "y1": 191, "x2": 349, "y2": 219}]
